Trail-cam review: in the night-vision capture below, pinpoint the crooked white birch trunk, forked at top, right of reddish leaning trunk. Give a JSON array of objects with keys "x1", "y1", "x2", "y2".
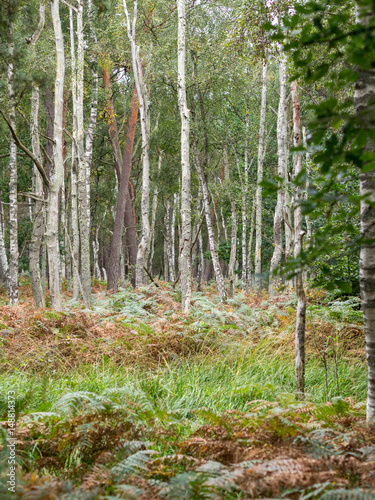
[{"x1": 124, "y1": 0, "x2": 150, "y2": 287}]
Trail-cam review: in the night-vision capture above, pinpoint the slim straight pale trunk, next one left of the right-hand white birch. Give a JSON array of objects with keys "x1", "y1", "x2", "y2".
[{"x1": 255, "y1": 59, "x2": 267, "y2": 286}]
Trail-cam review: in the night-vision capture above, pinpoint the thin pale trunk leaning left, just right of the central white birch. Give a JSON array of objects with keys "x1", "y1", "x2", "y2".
[{"x1": 194, "y1": 144, "x2": 227, "y2": 302}]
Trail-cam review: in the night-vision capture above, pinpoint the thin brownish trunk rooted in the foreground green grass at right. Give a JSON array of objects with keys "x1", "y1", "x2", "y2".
[{"x1": 291, "y1": 80, "x2": 306, "y2": 399}]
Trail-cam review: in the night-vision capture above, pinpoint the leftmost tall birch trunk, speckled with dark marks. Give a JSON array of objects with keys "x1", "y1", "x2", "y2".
[{"x1": 8, "y1": 23, "x2": 18, "y2": 305}]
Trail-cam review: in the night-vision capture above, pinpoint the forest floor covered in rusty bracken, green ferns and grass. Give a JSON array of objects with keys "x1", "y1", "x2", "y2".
[{"x1": 0, "y1": 279, "x2": 375, "y2": 500}]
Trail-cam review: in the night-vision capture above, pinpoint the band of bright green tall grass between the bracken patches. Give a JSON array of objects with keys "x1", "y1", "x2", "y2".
[{"x1": 0, "y1": 340, "x2": 367, "y2": 418}]
